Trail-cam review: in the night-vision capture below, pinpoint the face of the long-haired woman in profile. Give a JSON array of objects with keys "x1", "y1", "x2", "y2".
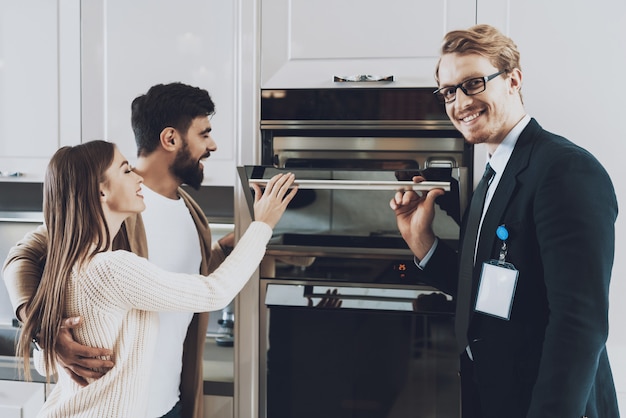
[{"x1": 100, "y1": 147, "x2": 146, "y2": 220}]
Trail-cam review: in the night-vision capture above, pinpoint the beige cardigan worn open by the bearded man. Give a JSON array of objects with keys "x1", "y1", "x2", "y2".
[{"x1": 3, "y1": 188, "x2": 225, "y2": 418}]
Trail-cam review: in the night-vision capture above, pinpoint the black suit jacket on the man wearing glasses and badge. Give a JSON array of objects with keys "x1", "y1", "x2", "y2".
[{"x1": 425, "y1": 119, "x2": 619, "y2": 418}]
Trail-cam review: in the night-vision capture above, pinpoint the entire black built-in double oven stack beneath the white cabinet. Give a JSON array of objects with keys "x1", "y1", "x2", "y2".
[{"x1": 238, "y1": 88, "x2": 473, "y2": 418}]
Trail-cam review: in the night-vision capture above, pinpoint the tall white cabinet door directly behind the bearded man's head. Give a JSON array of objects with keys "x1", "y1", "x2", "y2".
[{"x1": 82, "y1": 0, "x2": 238, "y2": 186}]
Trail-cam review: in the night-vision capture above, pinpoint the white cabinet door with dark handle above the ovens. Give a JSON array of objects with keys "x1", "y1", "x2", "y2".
[{"x1": 261, "y1": 0, "x2": 476, "y2": 88}]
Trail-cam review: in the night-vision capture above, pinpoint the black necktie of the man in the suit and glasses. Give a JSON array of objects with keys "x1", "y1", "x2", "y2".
[{"x1": 454, "y1": 164, "x2": 495, "y2": 352}]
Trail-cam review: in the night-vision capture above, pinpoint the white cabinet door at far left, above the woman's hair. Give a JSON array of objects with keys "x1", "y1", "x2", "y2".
[{"x1": 0, "y1": 0, "x2": 80, "y2": 182}]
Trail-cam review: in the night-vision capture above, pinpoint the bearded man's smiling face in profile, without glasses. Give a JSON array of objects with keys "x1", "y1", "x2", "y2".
[{"x1": 171, "y1": 116, "x2": 217, "y2": 189}]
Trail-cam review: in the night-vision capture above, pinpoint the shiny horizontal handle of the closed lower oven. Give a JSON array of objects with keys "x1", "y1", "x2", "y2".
[{"x1": 265, "y1": 283, "x2": 454, "y2": 313}]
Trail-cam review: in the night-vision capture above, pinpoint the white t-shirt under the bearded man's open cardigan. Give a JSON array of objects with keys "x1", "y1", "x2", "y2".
[{"x1": 141, "y1": 185, "x2": 202, "y2": 417}]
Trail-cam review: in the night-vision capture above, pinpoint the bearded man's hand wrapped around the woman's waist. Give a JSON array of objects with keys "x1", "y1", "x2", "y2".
[{"x1": 55, "y1": 317, "x2": 115, "y2": 386}]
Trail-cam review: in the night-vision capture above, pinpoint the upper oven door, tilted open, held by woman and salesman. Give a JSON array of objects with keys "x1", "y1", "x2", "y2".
[{"x1": 238, "y1": 166, "x2": 466, "y2": 256}]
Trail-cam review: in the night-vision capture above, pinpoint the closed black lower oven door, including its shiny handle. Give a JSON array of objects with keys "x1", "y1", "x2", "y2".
[{"x1": 260, "y1": 278, "x2": 460, "y2": 418}]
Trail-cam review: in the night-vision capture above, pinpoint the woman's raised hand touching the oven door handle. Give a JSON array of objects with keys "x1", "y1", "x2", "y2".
[{"x1": 252, "y1": 173, "x2": 298, "y2": 228}]
